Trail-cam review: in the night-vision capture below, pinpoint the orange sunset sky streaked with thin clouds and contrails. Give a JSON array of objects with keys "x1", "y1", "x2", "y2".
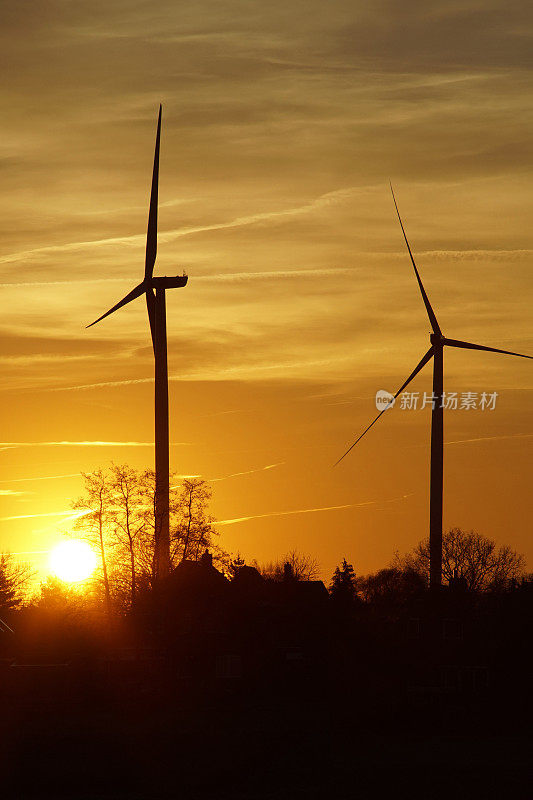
[{"x1": 0, "y1": 0, "x2": 533, "y2": 579}]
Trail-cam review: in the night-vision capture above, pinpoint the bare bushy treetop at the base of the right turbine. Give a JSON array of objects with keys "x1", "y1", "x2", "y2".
[{"x1": 396, "y1": 528, "x2": 524, "y2": 592}]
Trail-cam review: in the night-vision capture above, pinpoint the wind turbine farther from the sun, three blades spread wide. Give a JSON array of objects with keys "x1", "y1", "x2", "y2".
[{"x1": 335, "y1": 185, "x2": 533, "y2": 589}]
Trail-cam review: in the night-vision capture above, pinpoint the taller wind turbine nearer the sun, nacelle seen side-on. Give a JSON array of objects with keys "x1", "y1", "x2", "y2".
[{"x1": 87, "y1": 105, "x2": 187, "y2": 578}]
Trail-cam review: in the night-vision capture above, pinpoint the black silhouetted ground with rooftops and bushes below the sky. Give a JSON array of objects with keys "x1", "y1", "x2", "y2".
[{"x1": 0, "y1": 565, "x2": 533, "y2": 800}]
